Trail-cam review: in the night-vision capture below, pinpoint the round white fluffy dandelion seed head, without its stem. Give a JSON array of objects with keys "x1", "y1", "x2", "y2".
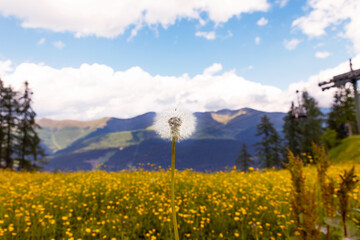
[{"x1": 155, "y1": 108, "x2": 196, "y2": 141}]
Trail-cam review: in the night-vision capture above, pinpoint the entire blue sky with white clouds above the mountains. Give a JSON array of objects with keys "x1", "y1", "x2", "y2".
[{"x1": 0, "y1": 0, "x2": 360, "y2": 120}]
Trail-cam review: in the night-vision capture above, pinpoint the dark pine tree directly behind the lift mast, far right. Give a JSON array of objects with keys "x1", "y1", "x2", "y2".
[{"x1": 327, "y1": 88, "x2": 358, "y2": 139}]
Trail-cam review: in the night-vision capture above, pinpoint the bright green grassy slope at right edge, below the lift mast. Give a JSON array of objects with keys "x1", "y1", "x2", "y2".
[{"x1": 330, "y1": 136, "x2": 360, "y2": 163}]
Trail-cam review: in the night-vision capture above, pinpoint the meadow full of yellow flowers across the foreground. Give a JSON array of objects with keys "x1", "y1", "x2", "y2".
[{"x1": 0, "y1": 164, "x2": 360, "y2": 240}]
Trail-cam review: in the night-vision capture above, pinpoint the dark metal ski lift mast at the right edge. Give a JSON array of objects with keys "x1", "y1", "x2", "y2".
[{"x1": 319, "y1": 58, "x2": 360, "y2": 133}]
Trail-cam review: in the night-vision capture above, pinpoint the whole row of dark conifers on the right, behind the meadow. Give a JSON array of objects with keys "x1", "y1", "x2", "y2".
[{"x1": 235, "y1": 87, "x2": 359, "y2": 171}]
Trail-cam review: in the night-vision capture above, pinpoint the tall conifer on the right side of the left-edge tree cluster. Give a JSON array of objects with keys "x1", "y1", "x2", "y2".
[{"x1": 17, "y1": 82, "x2": 44, "y2": 170}]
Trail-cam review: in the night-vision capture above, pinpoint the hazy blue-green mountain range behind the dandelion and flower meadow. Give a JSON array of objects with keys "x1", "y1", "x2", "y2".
[{"x1": 37, "y1": 108, "x2": 285, "y2": 171}]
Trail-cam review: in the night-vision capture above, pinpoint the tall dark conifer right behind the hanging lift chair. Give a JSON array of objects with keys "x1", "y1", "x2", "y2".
[{"x1": 300, "y1": 91, "x2": 323, "y2": 154}]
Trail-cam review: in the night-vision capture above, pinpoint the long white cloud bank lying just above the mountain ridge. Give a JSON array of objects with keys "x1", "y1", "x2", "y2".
[{"x1": 0, "y1": 55, "x2": 360, "y2": 120}]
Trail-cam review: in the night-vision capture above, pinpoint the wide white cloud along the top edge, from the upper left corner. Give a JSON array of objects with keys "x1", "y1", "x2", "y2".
[{"x1": 0, "y1": 0, "x2": 270, "y2": 38}]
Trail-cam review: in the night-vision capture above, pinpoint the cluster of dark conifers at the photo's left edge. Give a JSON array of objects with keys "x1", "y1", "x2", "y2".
[{"x1": 0, "y1": 79, "x2": 45, "y2": 170}]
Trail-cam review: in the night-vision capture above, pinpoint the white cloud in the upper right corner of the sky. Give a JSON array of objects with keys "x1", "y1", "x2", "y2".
[{"x1": 292, "y1": 0, "x2": 360, "y2": 53}]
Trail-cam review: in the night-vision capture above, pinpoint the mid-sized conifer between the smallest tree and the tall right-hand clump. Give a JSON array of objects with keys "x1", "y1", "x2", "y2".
[{"x1": 256, "y1": 115, "x2": 281, "y2": 168}]
